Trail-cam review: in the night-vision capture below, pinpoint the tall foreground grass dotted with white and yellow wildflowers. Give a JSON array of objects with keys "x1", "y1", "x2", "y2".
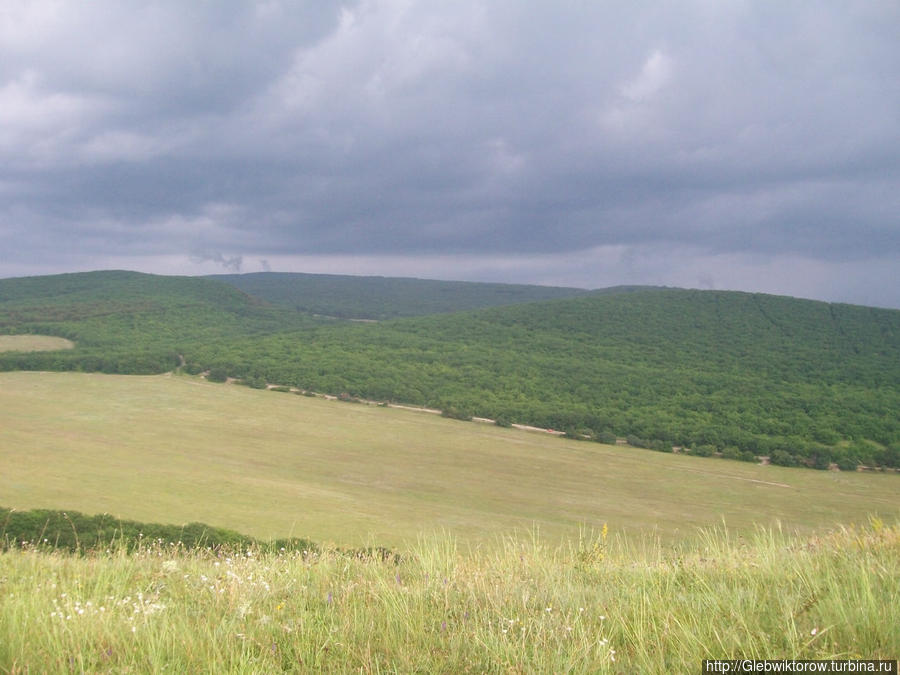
[{"x1": 0, "y1": 521, "x2": 900, "y2": 673}]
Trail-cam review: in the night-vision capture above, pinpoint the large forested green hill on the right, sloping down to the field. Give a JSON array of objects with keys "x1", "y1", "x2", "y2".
[{"x1": 190, "y1": 290, "x2": 900, "y2": 466}]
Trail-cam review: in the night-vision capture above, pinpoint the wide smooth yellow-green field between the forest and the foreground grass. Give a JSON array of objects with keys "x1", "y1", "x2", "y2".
[{"x1": 0, "y1": 372, "x2": 900, "y2": 546}]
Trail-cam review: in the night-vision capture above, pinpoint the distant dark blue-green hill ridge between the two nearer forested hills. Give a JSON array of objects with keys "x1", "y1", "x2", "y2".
[{"x1": 207, "y1": 272, "x2": 589, "y2": 319}]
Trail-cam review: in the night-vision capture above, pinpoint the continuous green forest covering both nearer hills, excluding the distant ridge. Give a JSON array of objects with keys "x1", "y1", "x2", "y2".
[{"x1": 0, "y1": 272, "x2": 900, "y2": 469}]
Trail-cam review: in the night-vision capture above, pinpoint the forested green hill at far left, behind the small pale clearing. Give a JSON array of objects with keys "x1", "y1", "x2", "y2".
[{"x1": 0, "y1": 271, "x2": 312, "y2": 373}]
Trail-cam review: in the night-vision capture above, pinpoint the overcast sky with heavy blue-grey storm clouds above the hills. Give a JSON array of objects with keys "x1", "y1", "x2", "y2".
[{"x1": 0, "y1": 0, "x2": 900, "y2": 308}]
